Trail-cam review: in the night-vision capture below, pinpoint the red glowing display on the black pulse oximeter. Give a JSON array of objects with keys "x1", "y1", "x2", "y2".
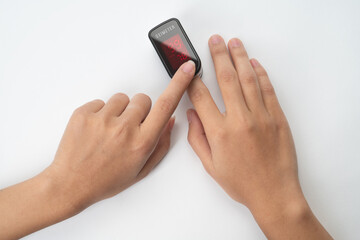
[{"x1": 161, "y1": 34, "x2": 190, "y2": 70}]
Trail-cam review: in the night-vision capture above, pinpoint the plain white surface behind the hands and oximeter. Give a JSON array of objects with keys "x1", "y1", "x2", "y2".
[{"x1": 0, "y1": 0, "x2": 360, "y2": 240}]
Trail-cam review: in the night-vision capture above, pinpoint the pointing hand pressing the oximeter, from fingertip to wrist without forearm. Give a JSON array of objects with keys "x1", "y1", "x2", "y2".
[{"x1": 46, "y1": 61, "x2": 195, "y2": 209}]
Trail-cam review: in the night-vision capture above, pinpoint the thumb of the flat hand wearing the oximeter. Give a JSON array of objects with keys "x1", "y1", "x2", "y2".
[{"x1": 186, "y1": 109, "x2": 214, "y2": 175}]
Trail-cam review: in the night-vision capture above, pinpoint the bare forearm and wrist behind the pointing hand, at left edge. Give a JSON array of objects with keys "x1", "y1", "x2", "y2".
[{"x1": 0, "y1": 171, "x2": 84, "y2": 239}]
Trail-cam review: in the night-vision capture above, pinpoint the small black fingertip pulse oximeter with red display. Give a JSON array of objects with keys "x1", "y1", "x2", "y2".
[{"x1": 149, "y1": 18, "x2": 202, "y2": 77}]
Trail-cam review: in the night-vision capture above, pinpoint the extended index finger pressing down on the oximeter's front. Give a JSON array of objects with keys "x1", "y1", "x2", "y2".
[{"x1": 140, "y1": 60, "x2": 195, "y2": 139}]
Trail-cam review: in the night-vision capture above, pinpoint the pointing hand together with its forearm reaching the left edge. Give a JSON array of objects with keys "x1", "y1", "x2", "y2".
[{"x1": 0, "y1": 62, "x2": 195, "y2": 239}]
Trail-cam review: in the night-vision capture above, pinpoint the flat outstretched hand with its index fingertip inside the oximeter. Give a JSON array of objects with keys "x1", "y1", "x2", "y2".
[{"x1": 187, "y1": 35, "x2": 329, "y2": 239}]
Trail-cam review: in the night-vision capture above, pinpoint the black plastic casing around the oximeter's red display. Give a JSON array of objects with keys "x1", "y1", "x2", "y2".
[{"x1": 148, "y1": 18, "x2": 202, "y2": 78}]
